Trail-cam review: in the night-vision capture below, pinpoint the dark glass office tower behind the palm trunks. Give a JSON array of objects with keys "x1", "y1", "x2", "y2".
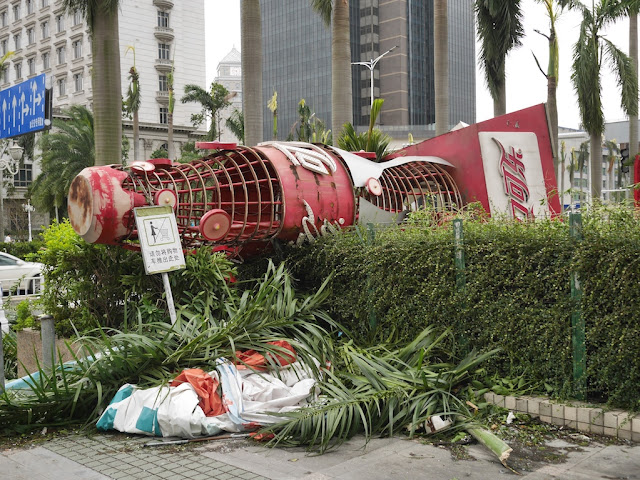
[{"x1": 261, "y1": 0, "x2": 476, "y2": 142}]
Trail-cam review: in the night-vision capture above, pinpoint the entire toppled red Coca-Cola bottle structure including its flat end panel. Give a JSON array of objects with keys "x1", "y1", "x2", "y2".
[{"x1": 69, "y1": 105, "x2": 560, "y2": 255}]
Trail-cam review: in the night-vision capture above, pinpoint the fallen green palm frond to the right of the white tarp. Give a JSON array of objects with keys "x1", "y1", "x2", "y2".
[{"x1": 265, "y1": 327, "x2": 495, "y2": 453}]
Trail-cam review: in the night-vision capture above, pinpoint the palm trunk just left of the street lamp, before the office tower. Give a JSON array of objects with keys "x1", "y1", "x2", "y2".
[{"x1": 332, "y1": 0, "x2": 353, "y2": 144}]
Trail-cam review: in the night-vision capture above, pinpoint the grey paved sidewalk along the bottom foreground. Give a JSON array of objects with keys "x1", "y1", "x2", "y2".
[{"x1": 0, "y1": 434, "x2": 640, "y2": 480}]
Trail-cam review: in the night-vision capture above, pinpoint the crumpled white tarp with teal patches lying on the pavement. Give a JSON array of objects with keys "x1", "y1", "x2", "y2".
[{"x1": 97, "y1": 359, "x2": 316, "y2": 438}]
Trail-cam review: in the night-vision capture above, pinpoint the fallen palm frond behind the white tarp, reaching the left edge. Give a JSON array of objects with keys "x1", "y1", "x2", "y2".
[{"x1": 0, "y1": 265, "x2": 333, "y2": 429}]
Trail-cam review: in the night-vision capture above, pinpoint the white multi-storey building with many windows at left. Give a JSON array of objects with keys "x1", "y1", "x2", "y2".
[{"x1": 0, "y1": 0, "x2": 205, "y2": 235}]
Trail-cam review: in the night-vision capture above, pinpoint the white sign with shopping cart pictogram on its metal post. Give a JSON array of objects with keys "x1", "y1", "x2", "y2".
[{"x1": 133, "y1": 206, "x2": 185, "y2": 325}]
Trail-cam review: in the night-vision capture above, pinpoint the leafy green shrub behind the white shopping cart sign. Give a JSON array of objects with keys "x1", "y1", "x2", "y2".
[{"x1": 37, "y1": 220, "x2": 235, "y2": 336}]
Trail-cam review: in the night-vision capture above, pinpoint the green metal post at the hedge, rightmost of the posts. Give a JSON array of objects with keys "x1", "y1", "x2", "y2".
[{"x1": 569, "y1": 213, "x2": 587, "y2": 400}]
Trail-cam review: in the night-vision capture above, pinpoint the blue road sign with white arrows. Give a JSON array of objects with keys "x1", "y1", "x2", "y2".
[{"x1": 0, "y1": 73, "x2": 51, "y2": 139}]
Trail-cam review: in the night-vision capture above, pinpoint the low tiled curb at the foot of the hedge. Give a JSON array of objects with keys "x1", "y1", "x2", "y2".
[{"x1": 484, "y1": 392, "x2": 640, "y2": 442}]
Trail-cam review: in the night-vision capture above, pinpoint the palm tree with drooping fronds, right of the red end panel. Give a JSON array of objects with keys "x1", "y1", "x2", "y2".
[{"x1": 570, "y1": 0, "x2": 638, "y2": 201}]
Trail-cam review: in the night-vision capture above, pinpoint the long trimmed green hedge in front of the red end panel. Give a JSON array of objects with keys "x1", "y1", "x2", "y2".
[{"x1": 287, "y1": 209, "x2": 640, "y2": 409}]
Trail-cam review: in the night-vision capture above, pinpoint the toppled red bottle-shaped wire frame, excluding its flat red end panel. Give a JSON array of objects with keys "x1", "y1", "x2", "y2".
[{"x1": 69, "y1": 142, "x2": 461, "y2": 252}]
